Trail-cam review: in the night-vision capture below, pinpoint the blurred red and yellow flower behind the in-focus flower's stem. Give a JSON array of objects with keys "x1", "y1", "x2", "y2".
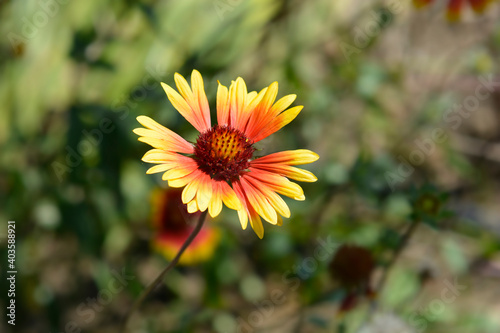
[{"x1": 151, "y1": 189, "x2": 220, "y2": 265}]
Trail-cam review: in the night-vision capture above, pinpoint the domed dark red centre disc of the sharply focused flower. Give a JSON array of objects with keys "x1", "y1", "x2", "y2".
[{"x1": 194, "y1": 125, "x2": 255, "y2": 181}]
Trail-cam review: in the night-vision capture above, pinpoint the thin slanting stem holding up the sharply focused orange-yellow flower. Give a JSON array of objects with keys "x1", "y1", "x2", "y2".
[{"x1": 120, "y1": 210, "x2": 208, "y2": 332}]
